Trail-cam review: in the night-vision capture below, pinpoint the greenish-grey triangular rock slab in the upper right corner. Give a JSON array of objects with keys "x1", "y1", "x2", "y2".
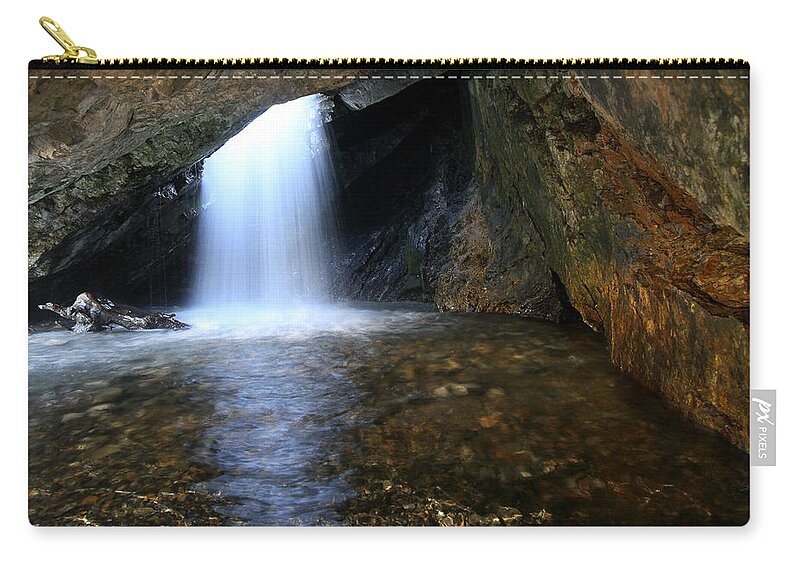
[{"x1": 580, "y1": 77, "x2": 750, "y2": 236}]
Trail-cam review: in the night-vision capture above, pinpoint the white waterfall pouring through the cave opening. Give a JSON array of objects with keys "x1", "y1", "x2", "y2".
[{"x1": 193, "y1": 95, "x2": 334, "y2": 321}]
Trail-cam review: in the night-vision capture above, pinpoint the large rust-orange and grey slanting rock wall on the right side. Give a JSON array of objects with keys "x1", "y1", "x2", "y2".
[{"x1": 471, "y1": 72, "x2": 749, "y2": 448}]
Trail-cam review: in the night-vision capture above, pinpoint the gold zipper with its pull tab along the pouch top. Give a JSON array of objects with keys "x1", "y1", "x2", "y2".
[{"x1": 34, "y1": 16, "x2": 750, "y2": 69}]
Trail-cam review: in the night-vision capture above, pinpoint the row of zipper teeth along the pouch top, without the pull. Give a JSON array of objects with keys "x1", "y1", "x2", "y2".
[{"x1": 30, "y1": 57, "x2": 750, "y2": 69}]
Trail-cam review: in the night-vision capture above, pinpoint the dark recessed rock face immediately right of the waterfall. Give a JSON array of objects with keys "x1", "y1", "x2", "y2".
[{"x1": 331, "y1": 82, "x2": 571, "y2": 321}]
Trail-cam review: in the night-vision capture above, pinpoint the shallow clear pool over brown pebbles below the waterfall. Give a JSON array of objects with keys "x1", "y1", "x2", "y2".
[{"x1": 29, "y1": 304, "x2": 749, "y2": 525}]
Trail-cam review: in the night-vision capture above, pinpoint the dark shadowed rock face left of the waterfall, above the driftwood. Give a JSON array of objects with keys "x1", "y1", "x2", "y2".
[{"x1": 28, "y1": 162, "x2": 203, "y2": 306}]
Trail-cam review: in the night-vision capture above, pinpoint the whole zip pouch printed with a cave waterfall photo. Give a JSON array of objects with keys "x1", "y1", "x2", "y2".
[{"x1": 28, "y1": 18, "x2": 749, "y2": 526}]
